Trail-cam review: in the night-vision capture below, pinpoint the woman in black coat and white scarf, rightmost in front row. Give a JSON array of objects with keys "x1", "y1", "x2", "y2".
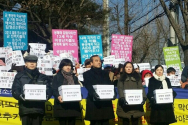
[{"x1": 147, "y1": 65, "x2": 176, "y2": 125}]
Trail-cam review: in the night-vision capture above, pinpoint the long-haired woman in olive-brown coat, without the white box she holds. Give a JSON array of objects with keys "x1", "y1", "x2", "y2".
[{"x1": 117, "y1": 62, "x2": 147, "y2": 125}]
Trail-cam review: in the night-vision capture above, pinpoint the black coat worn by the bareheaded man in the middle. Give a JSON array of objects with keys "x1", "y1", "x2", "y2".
[{"x1": 83, "y1": 68, "x2": 114, "y2": 120}]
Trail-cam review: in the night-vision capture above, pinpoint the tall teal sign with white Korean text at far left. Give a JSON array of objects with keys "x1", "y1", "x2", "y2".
[{"x1": 3, "y1": 11, "x2": 28, "y2": 50}]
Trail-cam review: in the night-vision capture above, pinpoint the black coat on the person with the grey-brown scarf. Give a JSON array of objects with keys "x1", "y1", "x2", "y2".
[{"x1": 52, "y1": 71, "x2": 81, "y2": 118}]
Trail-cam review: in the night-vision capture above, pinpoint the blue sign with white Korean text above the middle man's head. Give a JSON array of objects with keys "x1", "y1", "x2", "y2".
[{"x1": 79, "y1": 35, "x2": 103, "y2": 64}]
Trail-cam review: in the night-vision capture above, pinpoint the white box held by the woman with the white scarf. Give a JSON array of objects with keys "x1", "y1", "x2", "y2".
[{"x1": 153, "y1": 89, "x2": 173, "y2": 104}]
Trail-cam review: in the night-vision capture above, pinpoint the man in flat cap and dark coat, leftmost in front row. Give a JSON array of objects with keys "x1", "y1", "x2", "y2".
[{"x1": 12, "y1": 55, "x2": 52, "y2": 125}]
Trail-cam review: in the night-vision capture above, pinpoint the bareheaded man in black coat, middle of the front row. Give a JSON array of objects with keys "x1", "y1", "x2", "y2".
[{"x1": 83, "y1": 55, "x2": 116, "y2": 125}]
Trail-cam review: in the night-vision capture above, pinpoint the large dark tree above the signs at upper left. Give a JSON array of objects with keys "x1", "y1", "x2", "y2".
[{"x1": 0, "y1": 0, "x2": 103, "y2": 45}]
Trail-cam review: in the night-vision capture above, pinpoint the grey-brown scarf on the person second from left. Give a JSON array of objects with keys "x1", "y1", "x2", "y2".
[{"x1": 61, "y1": 70, "x2": 75, "y2": 85}]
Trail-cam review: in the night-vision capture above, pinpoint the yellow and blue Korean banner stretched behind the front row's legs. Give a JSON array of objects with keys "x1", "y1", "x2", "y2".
[{"x1": 0, "y1": 88, "x2": 188, "y2": 125}]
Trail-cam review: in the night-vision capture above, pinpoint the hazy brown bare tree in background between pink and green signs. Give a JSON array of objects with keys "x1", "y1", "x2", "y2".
[{"x1": 133, "y1": 16, "x2": 168, "y2": 64}]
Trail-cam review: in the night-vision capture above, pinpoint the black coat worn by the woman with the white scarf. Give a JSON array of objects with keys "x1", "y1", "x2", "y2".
[{"x1": 147, "y1": 77, "x2": 177, "y2": 124}]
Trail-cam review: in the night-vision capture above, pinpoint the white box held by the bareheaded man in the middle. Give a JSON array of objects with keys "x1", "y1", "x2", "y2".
[{"x1": 93, "y1": 85, "x2": 114, "y2": 99}]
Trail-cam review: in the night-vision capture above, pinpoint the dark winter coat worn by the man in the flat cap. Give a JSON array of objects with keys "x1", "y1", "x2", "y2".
[{"x1": 12, "y1": 70, "x2": 52, "y2": 116}]
